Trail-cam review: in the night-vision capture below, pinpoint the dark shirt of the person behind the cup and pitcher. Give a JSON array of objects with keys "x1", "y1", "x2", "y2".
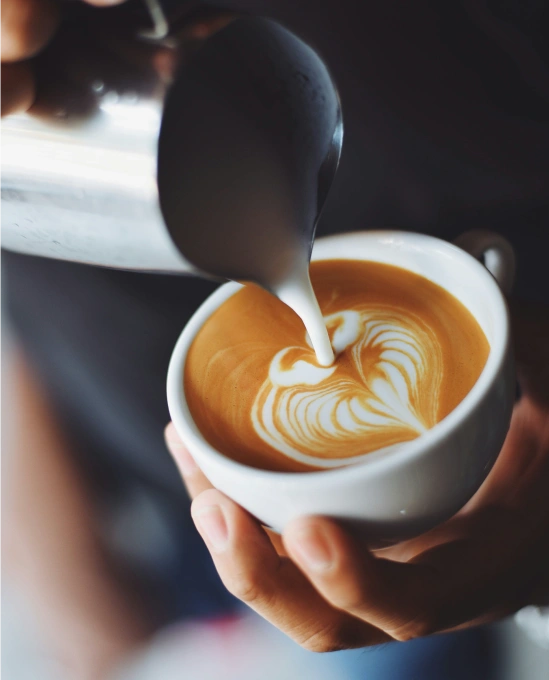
[{"x1": 4, "y1": 0, "x2": 549, "y2": 616}]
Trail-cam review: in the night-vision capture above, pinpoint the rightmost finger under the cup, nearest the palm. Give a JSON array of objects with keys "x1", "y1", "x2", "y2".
[{"x1": 284, "y1": 517, "x2": 439, "y2": 640}]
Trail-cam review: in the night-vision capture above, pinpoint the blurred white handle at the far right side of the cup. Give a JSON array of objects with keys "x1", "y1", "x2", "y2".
[{"x1": 454, "y1": 229, "x2": 516, "y2": 295}]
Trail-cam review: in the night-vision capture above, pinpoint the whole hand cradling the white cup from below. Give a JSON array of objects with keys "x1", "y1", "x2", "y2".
[{"x1": 166, "y1": 296, "x2": 549, "y2": 652}]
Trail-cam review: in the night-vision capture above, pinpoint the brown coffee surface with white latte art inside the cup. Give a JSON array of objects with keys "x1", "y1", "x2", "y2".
[{"x1": 184, "y1": 260, "x2": 490, "y2": 471}]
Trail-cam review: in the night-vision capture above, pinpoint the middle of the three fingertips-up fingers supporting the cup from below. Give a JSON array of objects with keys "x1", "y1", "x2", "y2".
[{"x1": 191, "y1": 489, "x2": 388, "y2": 651}]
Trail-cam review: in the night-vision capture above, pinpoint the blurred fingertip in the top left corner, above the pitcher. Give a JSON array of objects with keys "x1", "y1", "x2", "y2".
[{"x1": 0, "y1": 0, "x2": 59, "y2": 61}]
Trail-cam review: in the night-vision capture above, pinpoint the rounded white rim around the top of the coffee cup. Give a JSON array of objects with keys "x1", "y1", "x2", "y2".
[{"x1": 167, "y1": 230, "x2": 510, "y2": 486}]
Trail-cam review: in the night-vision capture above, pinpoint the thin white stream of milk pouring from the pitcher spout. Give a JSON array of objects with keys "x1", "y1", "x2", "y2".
[{"x1": 274, "y1": 267, "x2": 335, "y2": 366}]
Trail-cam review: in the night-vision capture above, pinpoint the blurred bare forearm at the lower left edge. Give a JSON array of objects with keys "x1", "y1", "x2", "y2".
[{"x1": 2, "y1": 356, "x2": 149, "y2": 678}]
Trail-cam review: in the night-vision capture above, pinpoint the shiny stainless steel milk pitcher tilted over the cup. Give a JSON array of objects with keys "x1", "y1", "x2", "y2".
[{"x1": 0, "y1": 0, "x2": 341, "y2": 279}]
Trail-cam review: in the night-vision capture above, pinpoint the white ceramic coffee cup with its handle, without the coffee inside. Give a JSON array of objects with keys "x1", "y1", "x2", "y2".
[{"x1": 168, "y1": 231, "x2": 515, "y2": 547}]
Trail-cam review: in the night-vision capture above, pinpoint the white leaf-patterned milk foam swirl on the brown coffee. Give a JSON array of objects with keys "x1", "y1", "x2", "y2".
[{"x1": 252, "y1": 305, "x2": 442, "y2": 468}]
